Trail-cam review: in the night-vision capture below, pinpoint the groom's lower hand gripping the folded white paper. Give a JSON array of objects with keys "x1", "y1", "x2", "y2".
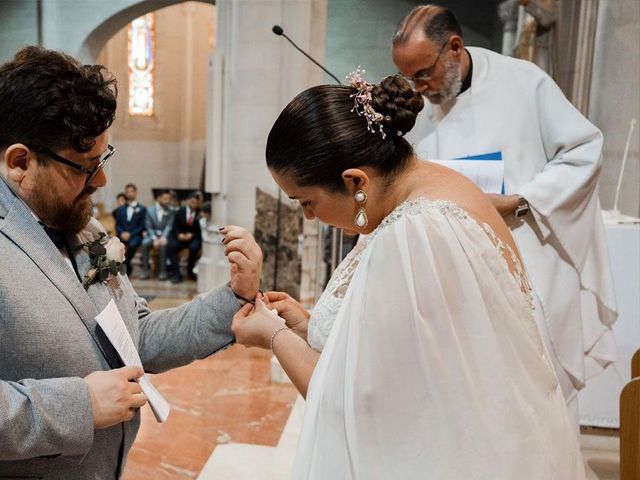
[{"x1": 84, "y1": 366, "x2": 147, "y2": 429}]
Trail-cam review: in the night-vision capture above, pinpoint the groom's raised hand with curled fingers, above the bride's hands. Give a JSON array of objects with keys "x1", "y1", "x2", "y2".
[{"x1": 220, "y1": 225, "x2": 262, "y2": 300}]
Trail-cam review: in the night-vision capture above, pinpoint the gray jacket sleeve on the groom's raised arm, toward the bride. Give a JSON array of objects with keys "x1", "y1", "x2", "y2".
[{"x1": 136, "y1": 286, "x2": 240, "y2": 373}]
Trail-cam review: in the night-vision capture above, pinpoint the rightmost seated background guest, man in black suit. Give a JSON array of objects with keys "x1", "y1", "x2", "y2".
[{"x1": 167, "y1": 192, "x2": 202, "y2": 283}]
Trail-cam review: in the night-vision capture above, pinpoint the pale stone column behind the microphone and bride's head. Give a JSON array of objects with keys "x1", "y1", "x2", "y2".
[{"x1": 198, "y1": 0, "x2": 327, "y2": 290}]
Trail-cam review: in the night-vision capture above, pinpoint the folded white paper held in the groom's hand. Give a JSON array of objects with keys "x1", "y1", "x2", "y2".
[{"x1": 96, "y1": 299, "x2": 171, "y2": 423}]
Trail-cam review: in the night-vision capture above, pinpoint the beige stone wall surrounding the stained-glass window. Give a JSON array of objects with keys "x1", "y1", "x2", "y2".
[{"x1": 95, "y1": 2, "x2": 215, "y2": 210}]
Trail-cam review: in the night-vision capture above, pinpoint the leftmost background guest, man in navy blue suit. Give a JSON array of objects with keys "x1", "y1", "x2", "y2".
[{"x1": 116, "y1": 183, "x2": 147, "y2": 276}]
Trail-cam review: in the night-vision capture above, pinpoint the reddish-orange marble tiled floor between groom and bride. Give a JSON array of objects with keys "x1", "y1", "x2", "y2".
[{"x1": 123, "y1": 281, "x2": 296, "y2": 480}]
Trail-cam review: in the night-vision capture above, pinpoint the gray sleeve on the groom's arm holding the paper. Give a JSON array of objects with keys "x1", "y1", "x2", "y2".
[{"x1": 0, "y1": 377, "x2": 94, "y2": 461}]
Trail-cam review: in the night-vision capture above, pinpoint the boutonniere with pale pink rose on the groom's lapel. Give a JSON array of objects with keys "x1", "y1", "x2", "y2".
[{"x1": 80, "y1": 232, "x2": 127, "y2": 290}]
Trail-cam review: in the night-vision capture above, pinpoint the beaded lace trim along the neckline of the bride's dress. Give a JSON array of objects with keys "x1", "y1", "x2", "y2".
[{"x1": 307, "y1": 197, "x2": 533, "y2": 352}]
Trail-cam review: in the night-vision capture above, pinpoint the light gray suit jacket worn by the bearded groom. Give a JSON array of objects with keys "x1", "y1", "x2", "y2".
[{"x1": 0, "y1": 177, "x2": 239, "y2": 480}]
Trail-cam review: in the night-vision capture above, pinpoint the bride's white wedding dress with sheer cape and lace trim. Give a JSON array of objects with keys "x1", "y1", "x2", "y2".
[{"x1": 293, "y1": 198, "x2": 584, "y2": 480}]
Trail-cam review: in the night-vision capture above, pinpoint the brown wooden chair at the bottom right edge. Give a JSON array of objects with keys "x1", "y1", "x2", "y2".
[{"x1": 620, "y1": 350, "x2": 640, "y2": 480}]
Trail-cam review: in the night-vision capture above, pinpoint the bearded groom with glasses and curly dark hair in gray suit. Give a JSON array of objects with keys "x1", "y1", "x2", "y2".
[{"x1": 0, "y1": 47, "x2": 262, "y2": 480}]
